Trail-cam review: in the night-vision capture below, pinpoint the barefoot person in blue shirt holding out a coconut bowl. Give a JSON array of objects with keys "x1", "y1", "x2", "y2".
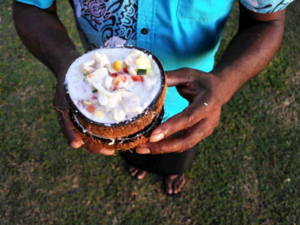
[{"x1": 13, "y1": 0, "x2": 292, "y2": 194}]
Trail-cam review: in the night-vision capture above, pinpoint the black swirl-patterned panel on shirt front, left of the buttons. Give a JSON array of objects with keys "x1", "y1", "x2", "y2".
[{"x1": 73, "y1": 0, "x2": 137, "y2": 45}]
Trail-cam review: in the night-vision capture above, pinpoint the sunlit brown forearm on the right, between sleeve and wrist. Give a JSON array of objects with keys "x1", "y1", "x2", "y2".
[{"x1": 212, "y1": 5, "x2": 284, "y2": 103}]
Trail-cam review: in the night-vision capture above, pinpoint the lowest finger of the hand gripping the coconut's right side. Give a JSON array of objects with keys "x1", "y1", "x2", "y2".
[{"x1": 136, "y1": 119, "x2": 215, "y2": 154}]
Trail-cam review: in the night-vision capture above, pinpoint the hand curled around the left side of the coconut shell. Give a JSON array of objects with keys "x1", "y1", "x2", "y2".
[{"x1": 53, "y1": 56, "x2": 115, "y2": 155}]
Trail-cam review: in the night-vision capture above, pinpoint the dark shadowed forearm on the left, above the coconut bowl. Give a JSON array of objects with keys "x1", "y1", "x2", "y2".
[{"x1": 13, "y1": 2, "x2": 79, "y2": 79}]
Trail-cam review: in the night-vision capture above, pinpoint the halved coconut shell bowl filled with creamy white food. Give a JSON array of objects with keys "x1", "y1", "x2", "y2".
[{"x1": 65, "y1": 46, "x2": 167, "y2": 150}]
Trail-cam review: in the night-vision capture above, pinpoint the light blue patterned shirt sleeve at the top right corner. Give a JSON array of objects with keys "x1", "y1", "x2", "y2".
[{"x1": 240, "y1": 0, "x2": 294, "y2": 13}]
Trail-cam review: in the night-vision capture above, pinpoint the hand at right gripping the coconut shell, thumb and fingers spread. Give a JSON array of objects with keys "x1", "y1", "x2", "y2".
[{"x1": 136, "y1": 68, "x2": 225, "y2": 154}]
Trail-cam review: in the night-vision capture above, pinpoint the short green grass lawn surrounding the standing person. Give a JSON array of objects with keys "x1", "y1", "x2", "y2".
[{"x1": 0, "y1": 1, "x2": 300, "y2": 224}]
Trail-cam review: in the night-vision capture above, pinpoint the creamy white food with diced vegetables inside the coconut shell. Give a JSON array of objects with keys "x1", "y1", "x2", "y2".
[{"x1": 65, "y1": 48, "x2": 161, "y2": 125}]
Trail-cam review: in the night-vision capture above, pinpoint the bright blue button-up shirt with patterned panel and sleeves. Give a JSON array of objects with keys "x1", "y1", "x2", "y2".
[{"x1": 18, "y1": 0, "x2": 292, "y2": 117}]
